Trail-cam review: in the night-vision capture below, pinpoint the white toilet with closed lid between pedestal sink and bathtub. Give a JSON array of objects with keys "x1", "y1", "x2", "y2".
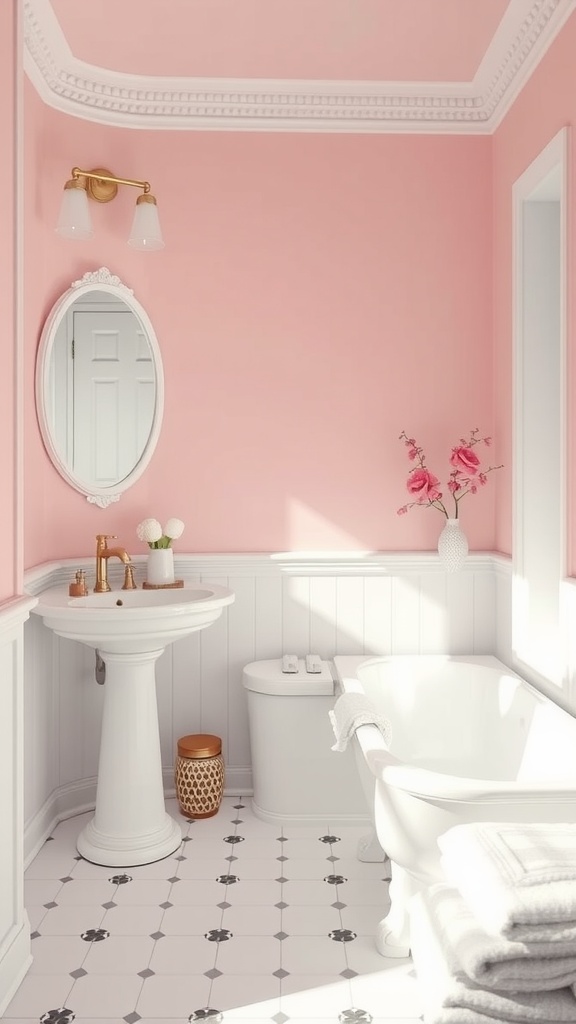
[{"x1": 242, "y1": 658, "x2": 369, "y2": 827}]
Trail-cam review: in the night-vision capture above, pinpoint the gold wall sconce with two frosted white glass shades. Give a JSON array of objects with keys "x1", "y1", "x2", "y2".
[{"x1": 56, "y1": 167, "x2": 164, "y2": 252}]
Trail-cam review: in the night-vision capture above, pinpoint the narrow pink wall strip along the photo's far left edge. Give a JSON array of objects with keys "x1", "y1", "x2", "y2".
[{"x1": 0, "y1": 0, "x2": 22, "y2": 601}]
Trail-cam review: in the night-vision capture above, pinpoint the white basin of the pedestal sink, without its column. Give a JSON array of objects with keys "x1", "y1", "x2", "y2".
[{"x1": 34, "y1": 584, "x2": 234, "y2": 656}]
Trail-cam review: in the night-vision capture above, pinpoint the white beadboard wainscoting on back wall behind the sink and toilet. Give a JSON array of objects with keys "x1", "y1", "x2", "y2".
[{"x1": 25, "y1": 552, "x2": 497, "y2": 861}]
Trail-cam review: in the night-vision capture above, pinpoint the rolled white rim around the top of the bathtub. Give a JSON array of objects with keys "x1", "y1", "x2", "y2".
[{"x1": 334, "y1": 654, "x2": 576, "y2": 809}]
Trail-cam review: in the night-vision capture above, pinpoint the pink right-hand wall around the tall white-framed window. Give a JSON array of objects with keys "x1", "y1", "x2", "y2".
[{"x1": 493, "y1": 14, "x2": 576, "y2": 574}]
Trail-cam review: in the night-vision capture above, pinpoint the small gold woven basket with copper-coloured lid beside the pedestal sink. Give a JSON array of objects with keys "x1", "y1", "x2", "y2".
[{"x1": 174, "y1": 732, "x2": 224, "y2": 818}]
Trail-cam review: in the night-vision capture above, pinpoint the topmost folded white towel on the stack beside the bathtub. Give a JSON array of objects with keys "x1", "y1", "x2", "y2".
[{"x1": 438, "y1": 822, "x2": 576, "y2": 943}]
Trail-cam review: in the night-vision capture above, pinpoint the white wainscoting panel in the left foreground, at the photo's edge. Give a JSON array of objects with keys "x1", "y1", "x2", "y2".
[{"x1": 0, "y1": 598, "x2": 36, "y2": 1016}]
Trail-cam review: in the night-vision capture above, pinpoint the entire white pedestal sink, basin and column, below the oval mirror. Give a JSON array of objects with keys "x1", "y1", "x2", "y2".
[{"x1": 33, "y1": 584, "x2": 235, "y2": 867}]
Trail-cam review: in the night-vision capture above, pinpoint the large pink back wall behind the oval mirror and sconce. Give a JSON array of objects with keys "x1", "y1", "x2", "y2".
[{"x1": 26, "y1": 83, "x2": 491, "y2": 565}]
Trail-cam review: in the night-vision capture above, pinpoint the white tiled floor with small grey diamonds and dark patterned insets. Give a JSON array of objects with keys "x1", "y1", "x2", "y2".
[{"x1": 4, "y1": 797, "x2": 421, "y2": 1024}]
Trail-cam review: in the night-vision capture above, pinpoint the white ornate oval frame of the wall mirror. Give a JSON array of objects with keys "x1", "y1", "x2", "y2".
[{"x1": 36, "y1": 267, "x2": 164, "y2": 508}]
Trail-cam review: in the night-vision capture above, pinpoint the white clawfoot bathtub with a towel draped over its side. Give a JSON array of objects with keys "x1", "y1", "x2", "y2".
[{"x1": 334, "y1": 655, "x2": 576, "y2": 956}]
